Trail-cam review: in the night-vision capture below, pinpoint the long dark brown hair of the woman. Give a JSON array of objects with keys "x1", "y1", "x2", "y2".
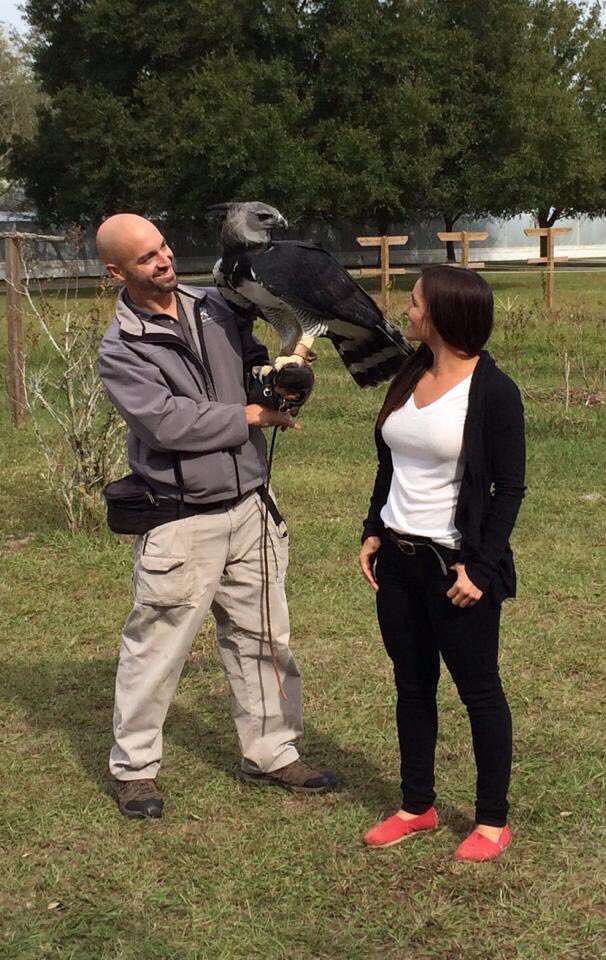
[{"x1": 377, "y1": 266, "x2": 493, "y2": 427}]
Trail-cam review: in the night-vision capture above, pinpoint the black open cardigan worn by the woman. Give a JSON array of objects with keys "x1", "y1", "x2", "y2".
[{"x1": 362, "y1": 350, "x2": 525, "y2": 602}]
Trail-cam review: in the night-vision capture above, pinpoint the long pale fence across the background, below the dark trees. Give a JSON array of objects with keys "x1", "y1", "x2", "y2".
[{"x1": 0, "y1": 214, "x2": 606, "y2": 281}]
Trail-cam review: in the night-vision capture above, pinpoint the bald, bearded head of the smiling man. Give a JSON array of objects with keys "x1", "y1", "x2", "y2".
[{"x1": 97, "y1": 213, "x2": 177, "y2": 302}]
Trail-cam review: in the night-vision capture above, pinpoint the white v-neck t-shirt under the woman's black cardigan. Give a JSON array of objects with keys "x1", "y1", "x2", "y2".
[{"x1": 381, "y1": 374, "x2": 471, "y2": 548}]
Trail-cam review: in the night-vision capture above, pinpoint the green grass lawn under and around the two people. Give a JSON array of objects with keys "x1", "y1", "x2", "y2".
[{"x1": 0, "y1": 273, "x2": 606, "y2": 960}]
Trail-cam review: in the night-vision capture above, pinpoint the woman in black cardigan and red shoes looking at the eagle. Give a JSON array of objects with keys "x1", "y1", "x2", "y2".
[{"x1": 359, "y1": 266, "x2": 524, "y2": 861}]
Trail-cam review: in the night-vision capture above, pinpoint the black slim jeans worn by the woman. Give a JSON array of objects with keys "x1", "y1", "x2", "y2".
[{"x1": 376, "y1": 541, "x2": 511, "y2": 827}]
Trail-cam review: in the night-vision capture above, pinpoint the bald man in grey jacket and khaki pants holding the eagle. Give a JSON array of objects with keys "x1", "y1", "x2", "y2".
[{"x1": 97, "y1": 214, "x2": 335, "y2": 817}]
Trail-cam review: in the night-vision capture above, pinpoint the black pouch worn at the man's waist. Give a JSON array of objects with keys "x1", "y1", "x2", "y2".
[{"x1": 103, "y1": 473, "x2": 181, "y2": 534}]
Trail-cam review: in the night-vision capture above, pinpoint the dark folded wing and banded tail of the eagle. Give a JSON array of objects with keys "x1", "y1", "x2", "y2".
[{"x1": 250, "y1": 241, "x2": 412, "y2": 387}]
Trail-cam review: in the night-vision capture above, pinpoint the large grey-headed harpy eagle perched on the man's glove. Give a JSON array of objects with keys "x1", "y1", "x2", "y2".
[{"x1": 208, "y1": 202, "x2": 412, "y2": 387}]
